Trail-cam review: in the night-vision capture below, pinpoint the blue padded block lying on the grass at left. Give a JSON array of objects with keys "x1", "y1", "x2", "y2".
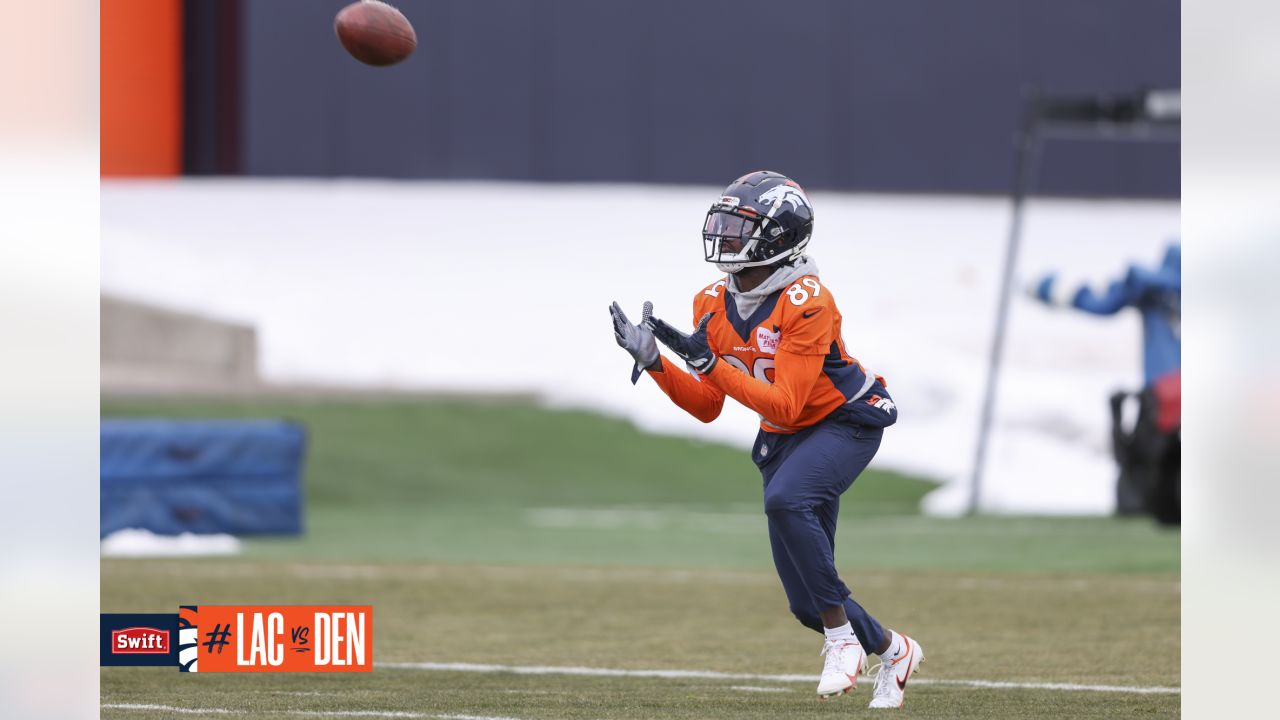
[{"x1": 100, "y1": 419, "x2": 306, "y2": 537}]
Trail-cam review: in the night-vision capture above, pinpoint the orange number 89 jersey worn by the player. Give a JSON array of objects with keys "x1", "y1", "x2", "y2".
[{"x1": 649, "y1": 275, "x2": 883, "y2": 433}]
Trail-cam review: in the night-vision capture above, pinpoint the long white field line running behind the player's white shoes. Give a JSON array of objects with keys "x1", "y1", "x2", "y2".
[{"x1": 374, "y1": 662, "x2": 1183, "y2": 694}]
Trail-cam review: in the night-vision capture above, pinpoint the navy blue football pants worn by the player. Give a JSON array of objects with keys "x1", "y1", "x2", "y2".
[{"x1": 751, "y1": 419, "x2": 884, "y2": 653}]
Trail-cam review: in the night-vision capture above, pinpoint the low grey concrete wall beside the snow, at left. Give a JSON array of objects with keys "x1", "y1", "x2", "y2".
[{"x1": 100, "y1": 296, "x2": 259, "y2": 395}]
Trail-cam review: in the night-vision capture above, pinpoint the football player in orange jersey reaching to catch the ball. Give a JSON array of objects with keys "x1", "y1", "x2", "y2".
[{"x1": 609, "y1": 170, "x2": 924, "y2": 707}]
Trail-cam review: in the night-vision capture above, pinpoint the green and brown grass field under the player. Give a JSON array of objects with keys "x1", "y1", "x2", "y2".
[{"x1": 101, "y1": 398, "x2": 1180, "y2": 720}]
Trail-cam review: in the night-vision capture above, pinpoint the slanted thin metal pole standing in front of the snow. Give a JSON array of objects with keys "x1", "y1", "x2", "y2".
[{"x1": 969, "y1": 91, "x2": 1039, "y2": 515}]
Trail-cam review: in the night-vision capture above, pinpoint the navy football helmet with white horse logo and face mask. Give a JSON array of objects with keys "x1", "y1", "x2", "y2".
[{"x1": 703, "y1": 170, "x2": 813, "y2": 273}]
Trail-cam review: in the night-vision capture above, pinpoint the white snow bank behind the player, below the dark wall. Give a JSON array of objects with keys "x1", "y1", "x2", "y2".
[{"x1": 101, "y1": 179, "x2": 1179, "y2": 514}]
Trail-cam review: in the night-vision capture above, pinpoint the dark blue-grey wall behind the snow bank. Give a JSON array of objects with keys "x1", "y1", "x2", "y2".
[{"x1": 239, "y1": 0, "x2": 1180, "y2": 196}]
